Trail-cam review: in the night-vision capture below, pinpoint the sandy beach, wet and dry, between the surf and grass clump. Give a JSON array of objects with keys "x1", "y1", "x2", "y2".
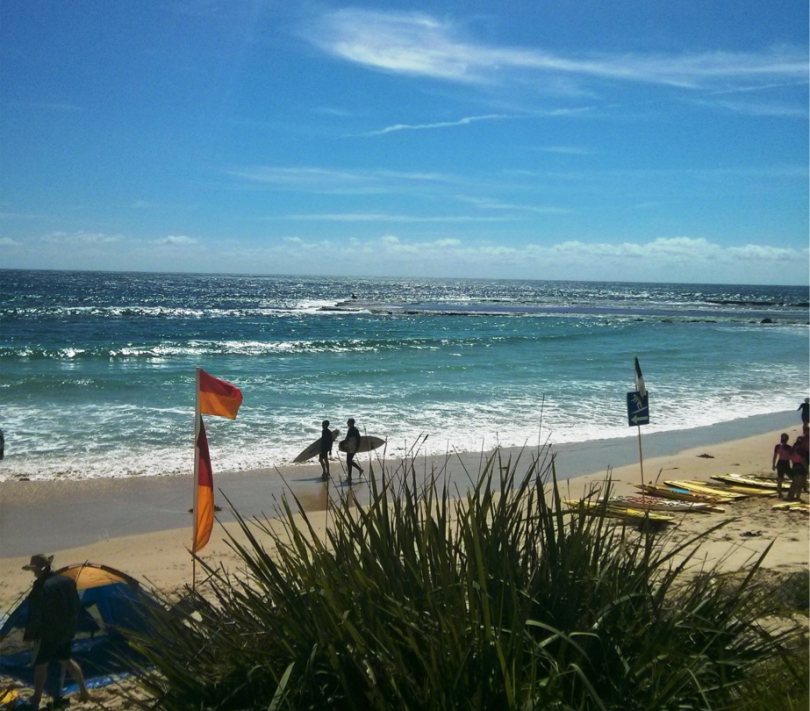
[{"x1": 0, "y1": 413, "x2": 810, "y2": 611}]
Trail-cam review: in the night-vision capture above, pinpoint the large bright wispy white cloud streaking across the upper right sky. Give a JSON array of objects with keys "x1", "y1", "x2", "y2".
[{"x1": 309, "y1": 8, "x2": 810, "y2": 89}]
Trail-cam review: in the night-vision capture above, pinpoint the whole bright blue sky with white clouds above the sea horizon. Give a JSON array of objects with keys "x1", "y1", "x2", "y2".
[{"x1": 0, "y1": 0, "x2": 810, "y2": 284}]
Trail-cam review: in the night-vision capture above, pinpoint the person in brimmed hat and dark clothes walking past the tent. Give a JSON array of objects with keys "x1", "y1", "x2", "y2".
[{"x1": 23, "y1": 553, "x2": 90, "y2": 709}]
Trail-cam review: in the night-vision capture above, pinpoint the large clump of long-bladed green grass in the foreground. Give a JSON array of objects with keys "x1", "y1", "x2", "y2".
[{"x1": 129, "y1": 458, "x2": 798, "y2": 711}]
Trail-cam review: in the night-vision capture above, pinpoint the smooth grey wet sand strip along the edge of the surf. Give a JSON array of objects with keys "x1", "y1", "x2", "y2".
[{"x1": 0, "y1": 411, "x2": 798, "y2": 558}]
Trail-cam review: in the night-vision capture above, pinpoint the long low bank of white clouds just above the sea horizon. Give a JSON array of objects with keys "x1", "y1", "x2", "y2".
[{"x1": 248, "y1": 234, "x2": 810, "y2": 283}]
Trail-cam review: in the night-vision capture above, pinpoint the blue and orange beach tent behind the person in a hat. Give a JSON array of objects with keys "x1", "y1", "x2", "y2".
[{"x1": 0, "y1": 563, "x2": 163, "y2": 696}]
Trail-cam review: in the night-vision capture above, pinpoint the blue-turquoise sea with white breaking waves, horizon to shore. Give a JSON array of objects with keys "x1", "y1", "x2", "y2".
[{"x1": 0, "y1": 270, "x2": 810, "y2": 481}]
